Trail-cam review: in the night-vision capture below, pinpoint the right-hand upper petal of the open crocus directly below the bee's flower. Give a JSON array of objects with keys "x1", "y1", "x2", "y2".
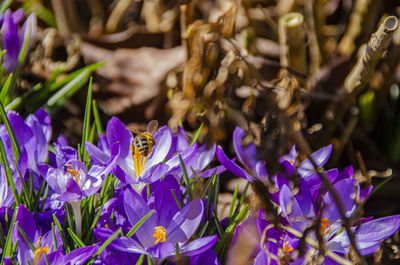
[{"x1": 166, "y1": 199, "x2": 203, "y2": 242}]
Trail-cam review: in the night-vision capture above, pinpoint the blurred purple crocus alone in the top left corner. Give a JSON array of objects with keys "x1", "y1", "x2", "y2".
[{"x1": 0, "y1": 9, "x2": 36, "y2": 73}]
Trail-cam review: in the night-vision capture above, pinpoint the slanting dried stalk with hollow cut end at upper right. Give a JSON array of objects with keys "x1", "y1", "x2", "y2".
[{"x1": 344, "y1": 16, "x2": 399, "y2": 94}]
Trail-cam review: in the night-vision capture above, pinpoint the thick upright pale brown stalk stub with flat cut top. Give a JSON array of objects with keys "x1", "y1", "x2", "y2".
[{"x1": 279, "y1": 12, "x2": 307, "y2": 75}]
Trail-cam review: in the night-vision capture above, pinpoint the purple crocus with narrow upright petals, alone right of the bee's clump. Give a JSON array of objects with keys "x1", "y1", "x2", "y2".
[{"x1": 216, "y1": 127, "x2": 268, "y2": 181}]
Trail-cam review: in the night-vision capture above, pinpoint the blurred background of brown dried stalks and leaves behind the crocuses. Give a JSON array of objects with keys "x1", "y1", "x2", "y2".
[{"x1": 10, "y1": 0, "x2": 400, "y2": 217}]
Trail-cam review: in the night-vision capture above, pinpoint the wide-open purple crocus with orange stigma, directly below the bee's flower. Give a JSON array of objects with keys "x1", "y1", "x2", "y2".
[{"x1": 95, "y1": 185, "x2": 217, "y2": 264}]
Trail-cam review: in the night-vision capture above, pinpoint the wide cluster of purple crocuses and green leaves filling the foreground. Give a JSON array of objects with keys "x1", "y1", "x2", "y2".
[{"x1": 0, "y1": 105, "x2": 400, "y2": 265}]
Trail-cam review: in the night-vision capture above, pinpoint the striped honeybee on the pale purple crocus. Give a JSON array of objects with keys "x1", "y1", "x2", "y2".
[{"x1": 129, "y1": 120, "x2": 158, "y2": 157}]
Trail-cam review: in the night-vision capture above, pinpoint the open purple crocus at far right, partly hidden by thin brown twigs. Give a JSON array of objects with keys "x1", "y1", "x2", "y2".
[{"x1": 279, "y1": 170, "x2": 400, "y2": 264}]
